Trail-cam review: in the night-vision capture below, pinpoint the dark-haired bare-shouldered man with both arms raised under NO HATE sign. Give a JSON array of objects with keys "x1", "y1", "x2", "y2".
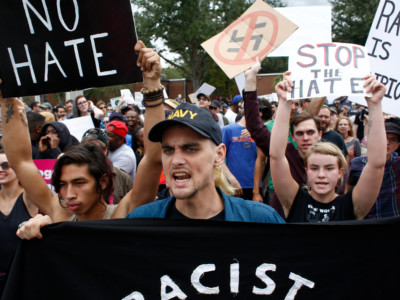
[{"x1": 1, "y1": 41, "x2": 164, "y2": 239}]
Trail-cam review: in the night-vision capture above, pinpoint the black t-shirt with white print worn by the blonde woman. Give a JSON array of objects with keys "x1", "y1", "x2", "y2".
[{"x1": 286, "y1": 186, "x2": 355, "y2": 223}]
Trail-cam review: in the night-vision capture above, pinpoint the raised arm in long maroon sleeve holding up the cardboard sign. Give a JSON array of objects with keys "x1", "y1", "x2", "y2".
[{"x1": 243, "y1": 62, "x2": 271, "y2": 156}]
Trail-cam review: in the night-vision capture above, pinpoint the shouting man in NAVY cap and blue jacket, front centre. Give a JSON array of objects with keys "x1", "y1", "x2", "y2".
[{"x1": 128, "y1": 103, "x2": 283, "y2": 223}]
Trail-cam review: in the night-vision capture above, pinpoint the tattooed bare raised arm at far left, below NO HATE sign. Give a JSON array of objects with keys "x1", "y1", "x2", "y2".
[{"x1": 0, "y1": 96, "x2": 65, "y2": 221}]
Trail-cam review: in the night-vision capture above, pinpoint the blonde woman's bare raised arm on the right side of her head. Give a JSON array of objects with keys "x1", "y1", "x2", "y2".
[{"x1": 353, "y1": 75, "x2": 386, "y2": 219}]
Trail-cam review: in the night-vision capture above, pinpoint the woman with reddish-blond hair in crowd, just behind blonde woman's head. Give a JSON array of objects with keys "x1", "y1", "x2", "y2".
[{"x1": 333, "y1": 117, "x2": 361, "y2": 161}]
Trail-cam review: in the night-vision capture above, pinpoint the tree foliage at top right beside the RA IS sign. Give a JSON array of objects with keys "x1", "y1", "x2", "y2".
[{"x1": 329, "y1": 0, "x2": 379, "y2": 45}]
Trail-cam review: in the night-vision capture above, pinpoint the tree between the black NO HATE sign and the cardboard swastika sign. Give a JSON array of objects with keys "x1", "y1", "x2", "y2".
[{"x1": 135, "y1": 0, "x2": 280, "y2": 89}]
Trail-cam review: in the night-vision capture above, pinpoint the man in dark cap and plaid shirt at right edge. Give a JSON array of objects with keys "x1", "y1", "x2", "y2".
[{"x1": 346, "y1": 118, "x2": 400, "y2": 219}]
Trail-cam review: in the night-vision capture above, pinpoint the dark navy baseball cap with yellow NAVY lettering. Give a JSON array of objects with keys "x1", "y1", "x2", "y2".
[{"x1": 149, "y1": 103, "x2": 222, "y2": 145}]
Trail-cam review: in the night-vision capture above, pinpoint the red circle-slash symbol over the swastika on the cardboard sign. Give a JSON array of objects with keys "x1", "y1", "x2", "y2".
[{"x1": 214, "y1": 11, "x2": 278, "y2": 65}]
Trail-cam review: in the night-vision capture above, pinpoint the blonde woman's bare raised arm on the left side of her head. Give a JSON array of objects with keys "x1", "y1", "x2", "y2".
[{"x1": 269, "y1": 72, "x2": 299, "y2": 217}]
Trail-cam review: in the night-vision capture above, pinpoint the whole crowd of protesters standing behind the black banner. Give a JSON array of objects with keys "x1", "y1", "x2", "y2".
[{"x1": 0, "y1": 42, "x2": 400, "y2": 292}]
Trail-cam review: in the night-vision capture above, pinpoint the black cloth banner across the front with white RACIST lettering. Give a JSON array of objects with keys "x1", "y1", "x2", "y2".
[{"x1": 2, "y1": 218, "x2": 400, "y2": 300}]
